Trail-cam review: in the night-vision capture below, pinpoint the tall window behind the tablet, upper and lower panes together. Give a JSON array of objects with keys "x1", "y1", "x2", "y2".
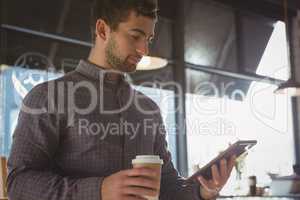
[{"x1": 185, "y1": 0, "x2": 295, "y2": 194}]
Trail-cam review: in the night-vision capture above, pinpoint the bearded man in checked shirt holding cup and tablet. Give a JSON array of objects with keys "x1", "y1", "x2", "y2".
[{"x1": 8, "y1": 0, "x2": 234, "y2": 200}]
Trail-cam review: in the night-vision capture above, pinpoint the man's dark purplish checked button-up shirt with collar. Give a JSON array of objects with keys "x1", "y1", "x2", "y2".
[{"x1": 7, "y1": 60, "x2": 200, "y2": 200}]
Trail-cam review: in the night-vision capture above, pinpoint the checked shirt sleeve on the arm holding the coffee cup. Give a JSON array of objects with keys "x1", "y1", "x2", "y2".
[{"x1": 7, "y1": 85, "x2": 103, "y2": 200}]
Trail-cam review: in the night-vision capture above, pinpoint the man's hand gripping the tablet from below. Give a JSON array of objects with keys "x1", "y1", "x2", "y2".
[{"x1": 198, "y1": 156, "x2": 236, "y2": 199}]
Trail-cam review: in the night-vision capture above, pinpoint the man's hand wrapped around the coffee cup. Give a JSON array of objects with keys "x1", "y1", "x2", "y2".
[{"x1": 101, "y1": 168, "x2": 159, "y2": 200}]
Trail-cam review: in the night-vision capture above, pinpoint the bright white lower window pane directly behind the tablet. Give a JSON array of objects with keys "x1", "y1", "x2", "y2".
[{"x1": 186, "y1": 74, "x2": 294, "y2": 194}]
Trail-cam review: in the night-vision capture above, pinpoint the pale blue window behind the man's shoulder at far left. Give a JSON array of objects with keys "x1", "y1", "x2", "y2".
[{"x1": 0, "y1": 65, "x2": 62, "y2": 156}]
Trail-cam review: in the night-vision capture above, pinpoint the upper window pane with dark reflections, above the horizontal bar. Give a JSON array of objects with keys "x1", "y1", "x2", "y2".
[{"x1": 185, "y1": 0, "x2": 289, "y2": 80}]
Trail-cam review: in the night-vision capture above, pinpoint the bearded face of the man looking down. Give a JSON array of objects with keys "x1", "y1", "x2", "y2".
[{"x1": 105, "y1": 11, "x2": 156, "y2": 72}]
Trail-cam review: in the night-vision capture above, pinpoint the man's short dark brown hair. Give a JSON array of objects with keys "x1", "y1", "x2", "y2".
[{"x1": 91, "y1": 0, "x2": 158, "y2": 40}]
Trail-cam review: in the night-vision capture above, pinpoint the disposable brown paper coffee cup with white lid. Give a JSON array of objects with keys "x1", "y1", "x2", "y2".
[{"x1": 132, "y1": 155, "x2": 163, "y2": 200}]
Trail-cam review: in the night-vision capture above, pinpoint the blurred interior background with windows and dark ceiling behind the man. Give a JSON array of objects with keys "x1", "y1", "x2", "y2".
[{"x1": 0, "y1": 0, "x2": 300, "y2": 195}]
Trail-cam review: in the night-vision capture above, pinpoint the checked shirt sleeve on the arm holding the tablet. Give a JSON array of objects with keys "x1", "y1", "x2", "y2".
[{"x1": 155, "y1": 111, "x2": 201, "y2": 200}]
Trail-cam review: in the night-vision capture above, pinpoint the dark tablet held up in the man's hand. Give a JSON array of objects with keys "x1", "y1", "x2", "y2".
[{"x1": 187, "y1": 140, "x2": 257, "y2": 181}]
